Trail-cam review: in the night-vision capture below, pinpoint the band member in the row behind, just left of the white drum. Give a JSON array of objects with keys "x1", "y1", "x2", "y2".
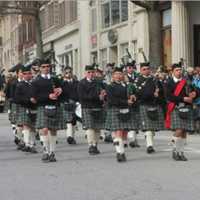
[{"x1": 61, "y1": 67, "x2": 78, "y2": 145}]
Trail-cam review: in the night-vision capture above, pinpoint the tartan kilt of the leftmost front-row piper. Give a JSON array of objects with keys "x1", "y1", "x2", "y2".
[{"x1": 16, "y1": 105, "x2": 35, "y2": 128}]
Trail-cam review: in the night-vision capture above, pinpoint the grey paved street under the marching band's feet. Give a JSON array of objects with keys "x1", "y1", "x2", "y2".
[{"x1": 0, "y1": 114, "x2": 200, "y2": 200}]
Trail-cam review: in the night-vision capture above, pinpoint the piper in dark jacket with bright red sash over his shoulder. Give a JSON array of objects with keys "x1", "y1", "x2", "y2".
[{"x1": 165, "y1": 63, "x2": 196, "y2": 161}]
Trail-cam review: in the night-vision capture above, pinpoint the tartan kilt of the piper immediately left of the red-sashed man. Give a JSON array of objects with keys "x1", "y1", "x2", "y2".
[{"x1": 139, "y1": 105, "x2": 165, "y2": 131}]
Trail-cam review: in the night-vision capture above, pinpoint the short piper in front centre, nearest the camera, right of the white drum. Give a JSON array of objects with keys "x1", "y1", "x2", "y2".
[{"x1": 105, "y1": 68, "x2": 138, "y2": 162}]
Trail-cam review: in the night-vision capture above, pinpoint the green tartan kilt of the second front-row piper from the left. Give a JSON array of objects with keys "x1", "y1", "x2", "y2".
[{"x1": 36, "y1": 106, "x2": 64, "y2": 130}]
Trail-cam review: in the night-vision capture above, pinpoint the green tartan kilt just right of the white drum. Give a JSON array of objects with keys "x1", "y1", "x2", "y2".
[{"x1": 82, "y1": 108, "x2": 106, "y2": 130}]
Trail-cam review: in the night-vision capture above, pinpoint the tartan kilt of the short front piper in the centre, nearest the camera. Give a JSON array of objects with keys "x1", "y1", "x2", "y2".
[{"x1": 105, "y1": 107, "x2": 139, "y2": 131}]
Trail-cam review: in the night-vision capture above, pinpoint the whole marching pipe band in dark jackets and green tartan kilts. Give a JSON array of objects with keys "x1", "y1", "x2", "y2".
[{"x1": 5, "y1": 60, "x2": 200, "y2": 162}]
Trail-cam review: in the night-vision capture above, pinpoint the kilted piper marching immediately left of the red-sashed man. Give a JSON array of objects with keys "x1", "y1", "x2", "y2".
[{"x1": 135, "y1": 63, "x2": 164, "y2": 154}]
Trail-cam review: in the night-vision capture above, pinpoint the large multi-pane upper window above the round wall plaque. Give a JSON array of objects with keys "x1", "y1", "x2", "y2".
[{"x1": 101, "y1": 0, "x2": 128, "y2": 28}]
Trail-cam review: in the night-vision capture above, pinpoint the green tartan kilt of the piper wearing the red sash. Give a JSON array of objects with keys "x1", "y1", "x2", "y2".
[{"x1": 171, "y1": 107, "x2": 195, "y2": 131}]
